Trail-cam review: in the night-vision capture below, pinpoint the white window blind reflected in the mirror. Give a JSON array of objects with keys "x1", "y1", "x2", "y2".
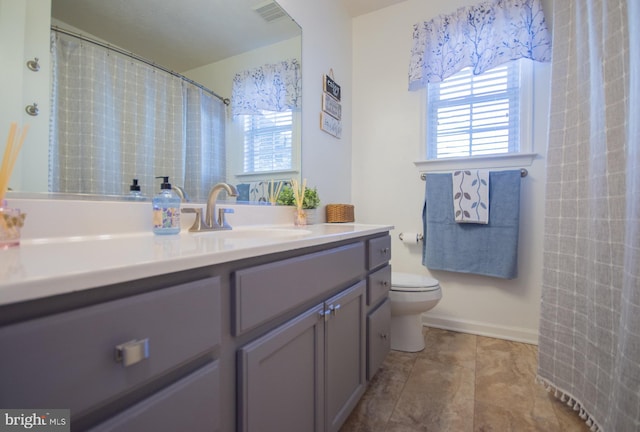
[{"x1": 244, "y1": 111, "x2": 293, "y2": 174}]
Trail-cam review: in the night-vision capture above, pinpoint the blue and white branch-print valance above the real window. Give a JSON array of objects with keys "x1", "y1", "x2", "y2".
[{"x1": 409, "y1": 0, "x2": 551, "y2": 90}]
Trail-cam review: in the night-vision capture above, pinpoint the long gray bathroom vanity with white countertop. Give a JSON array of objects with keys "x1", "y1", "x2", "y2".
[{"x1": 0, "y1": 219, "x2": 391, "y2": 432}]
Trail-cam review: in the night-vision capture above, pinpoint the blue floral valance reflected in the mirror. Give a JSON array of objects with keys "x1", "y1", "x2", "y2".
[{"x1": 231, "y1": 59, "x2": 302, "y2": 116}]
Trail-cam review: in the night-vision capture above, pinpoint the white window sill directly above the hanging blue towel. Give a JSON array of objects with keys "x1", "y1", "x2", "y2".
[{"x1": 414, "y1": 153, "x2": 538, "y2": 173}]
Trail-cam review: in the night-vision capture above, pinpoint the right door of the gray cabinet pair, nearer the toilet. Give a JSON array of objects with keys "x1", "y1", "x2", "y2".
[{"x1": 325, "y1": 281, "x2": 366, "y2": 432}]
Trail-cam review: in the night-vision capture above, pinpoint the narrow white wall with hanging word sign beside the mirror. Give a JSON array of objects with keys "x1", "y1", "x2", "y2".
[{"x1": 278, "y1": 0, "x2": 353, "y2": 219}]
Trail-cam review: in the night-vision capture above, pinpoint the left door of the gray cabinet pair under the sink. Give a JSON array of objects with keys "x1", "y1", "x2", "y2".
[{"x1": 238, "y1": 305, "x2": 324, "y2": 432}]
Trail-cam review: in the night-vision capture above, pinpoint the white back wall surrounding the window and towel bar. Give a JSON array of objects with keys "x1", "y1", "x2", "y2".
[{"x1": 348, "y1": 0, "x2": 550, "y2": 343}]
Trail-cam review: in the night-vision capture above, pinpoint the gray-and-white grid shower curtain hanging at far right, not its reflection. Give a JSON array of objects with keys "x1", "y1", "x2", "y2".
[{"x1": 538, "y1": 0, "x2": 640, "y2": 432}]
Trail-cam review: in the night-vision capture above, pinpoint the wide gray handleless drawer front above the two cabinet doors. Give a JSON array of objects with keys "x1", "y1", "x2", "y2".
[{"x1": 233, "y1": 242, "x2": 365, "y2": 336}]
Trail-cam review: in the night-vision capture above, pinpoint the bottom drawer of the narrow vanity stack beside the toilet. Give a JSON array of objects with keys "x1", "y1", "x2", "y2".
[{"x1": 367, "y1": 299, "x2": 391, "y2": 381}]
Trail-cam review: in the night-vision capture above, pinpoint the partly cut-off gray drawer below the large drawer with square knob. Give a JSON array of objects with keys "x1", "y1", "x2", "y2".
[{"x1": 90, "y1": 362, "x2": 220, "y2": 432}]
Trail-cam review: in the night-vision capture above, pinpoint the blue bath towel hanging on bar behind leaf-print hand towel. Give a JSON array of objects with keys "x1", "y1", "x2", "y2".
[{"x1": 422, "y1": 170, "x2": 520, "y2": 279}]
